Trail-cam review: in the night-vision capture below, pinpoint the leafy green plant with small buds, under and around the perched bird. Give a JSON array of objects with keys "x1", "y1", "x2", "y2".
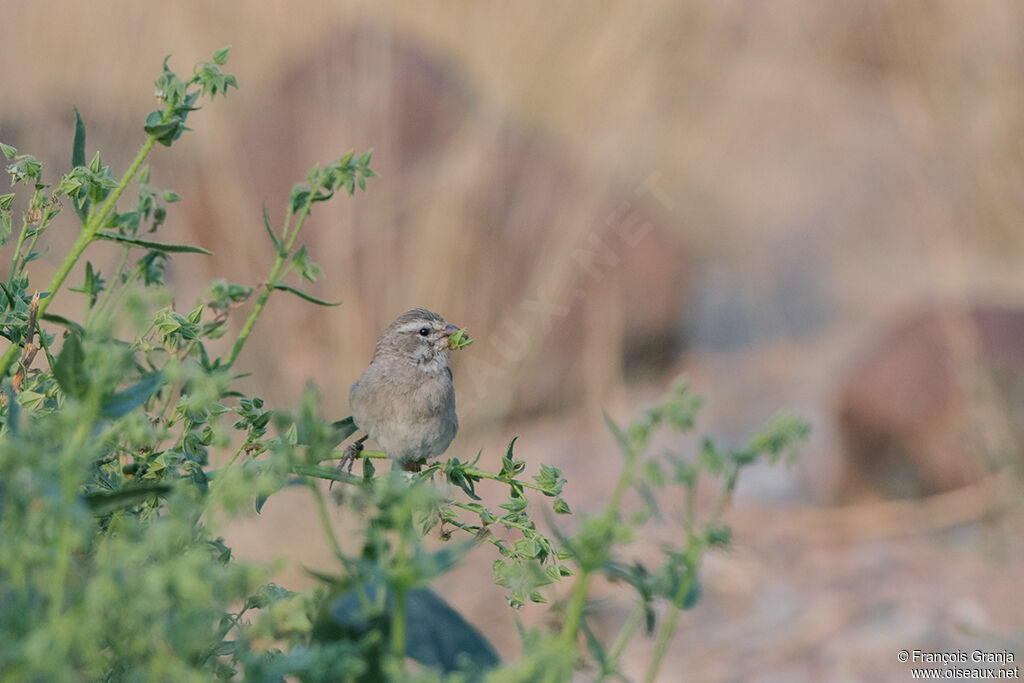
[{"x1": 0, "y1": 48, "x2": 807, "y2": 681}]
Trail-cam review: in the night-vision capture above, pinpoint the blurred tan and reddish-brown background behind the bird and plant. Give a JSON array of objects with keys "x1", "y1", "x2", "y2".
[{"x1": 0, "y1": 0, "x2": 1024, "y2": 681}]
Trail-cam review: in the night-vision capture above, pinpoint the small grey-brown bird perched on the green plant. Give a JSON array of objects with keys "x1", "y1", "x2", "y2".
[{"x1": 346, "y1": 308, "x2": 459, "y2": 470}]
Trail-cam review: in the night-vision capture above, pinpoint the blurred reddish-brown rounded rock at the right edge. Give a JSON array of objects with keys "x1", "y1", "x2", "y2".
[{"x1": 838, "y1": 304, "x2": 1024, "y2": 500}]
